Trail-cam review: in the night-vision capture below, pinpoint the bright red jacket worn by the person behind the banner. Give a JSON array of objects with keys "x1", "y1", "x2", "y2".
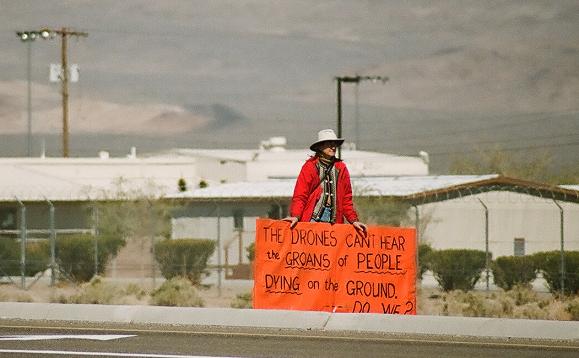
[{"x1": 290, "y1": 156, "x2": 358, "y2": 224}]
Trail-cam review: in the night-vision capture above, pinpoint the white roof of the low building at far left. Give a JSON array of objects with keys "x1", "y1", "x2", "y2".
[{"x1": 0, "y1": 158, "x2": 195, "y2": 202}]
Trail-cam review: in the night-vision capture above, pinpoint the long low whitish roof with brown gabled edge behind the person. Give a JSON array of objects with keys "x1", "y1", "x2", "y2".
[{"x1": 167, "y1": 174, "x2": 579, "y2": 204}]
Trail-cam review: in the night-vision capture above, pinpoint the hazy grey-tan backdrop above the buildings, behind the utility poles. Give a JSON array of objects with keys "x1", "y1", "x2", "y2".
[{"x1": 0, "y1": 0, "x2": 579, "y2": 164}]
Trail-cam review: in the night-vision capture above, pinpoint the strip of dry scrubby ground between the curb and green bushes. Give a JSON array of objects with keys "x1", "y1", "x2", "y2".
[{"x1": 0, "y1": 278, "x2": 579, "y2": 320}]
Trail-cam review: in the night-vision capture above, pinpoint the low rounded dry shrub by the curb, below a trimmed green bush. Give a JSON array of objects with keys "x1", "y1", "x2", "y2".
[{"x1": 151, "y1": 276, "x2": 205, "y2": 307}]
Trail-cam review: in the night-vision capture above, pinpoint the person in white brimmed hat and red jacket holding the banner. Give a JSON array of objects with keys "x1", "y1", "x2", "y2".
[{"x1": 283, "y1": 129, "x2": 367, "y2": 236}]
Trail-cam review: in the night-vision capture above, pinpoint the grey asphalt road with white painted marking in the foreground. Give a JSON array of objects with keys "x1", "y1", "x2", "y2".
[{"x1": 0, "y1": 321, "x2": 579, "y2": 358}]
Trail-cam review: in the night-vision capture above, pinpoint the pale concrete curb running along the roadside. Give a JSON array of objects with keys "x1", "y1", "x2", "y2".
[{"x1": 0, "y1": 302, "x2": 579, "y2": 341}]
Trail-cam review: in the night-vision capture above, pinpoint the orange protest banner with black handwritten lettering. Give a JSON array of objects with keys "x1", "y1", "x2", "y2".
[{"x1": 253, "y1": 219, "x2": 416, "y2": 314}]
